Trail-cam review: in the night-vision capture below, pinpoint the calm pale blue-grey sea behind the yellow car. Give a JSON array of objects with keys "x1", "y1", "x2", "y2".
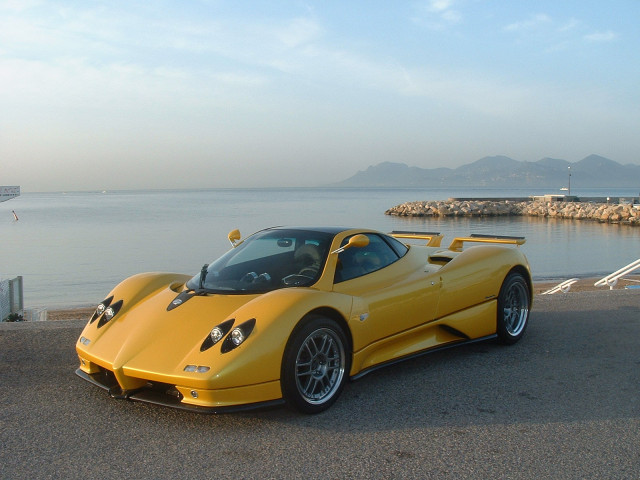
[{"x1": 0, "y1": 188, "x2": 640, "y2": 308}]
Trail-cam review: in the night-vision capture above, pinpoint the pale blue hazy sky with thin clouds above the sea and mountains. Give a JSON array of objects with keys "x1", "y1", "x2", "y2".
[{"x1": 0, "y1": 0, "x2": 640, "y2": 191}]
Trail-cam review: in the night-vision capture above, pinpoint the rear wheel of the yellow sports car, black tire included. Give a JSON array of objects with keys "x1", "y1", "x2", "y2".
[{"x1": 497, "y1": 272, "x2": 531, "y2": 345}]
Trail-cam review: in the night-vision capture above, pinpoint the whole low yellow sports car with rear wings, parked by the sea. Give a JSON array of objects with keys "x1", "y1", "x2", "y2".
[{"x1": 76, "y1": 227, "x2": 532, "y2": 413}]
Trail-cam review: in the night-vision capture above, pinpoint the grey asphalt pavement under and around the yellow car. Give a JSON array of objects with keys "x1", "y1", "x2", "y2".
[{"x1": 0, "y1": 291, "x2": 640, "y2": 480}]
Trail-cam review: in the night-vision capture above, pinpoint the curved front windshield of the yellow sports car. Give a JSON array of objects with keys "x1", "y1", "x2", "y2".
[{"x1": 187, "y1": 229, "x2": 333, "y2": 293}]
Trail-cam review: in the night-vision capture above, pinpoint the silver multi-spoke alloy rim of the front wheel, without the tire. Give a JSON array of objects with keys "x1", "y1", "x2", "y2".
[{"x1": 295, "y1": 328, "x2": 346, "y2": 405}]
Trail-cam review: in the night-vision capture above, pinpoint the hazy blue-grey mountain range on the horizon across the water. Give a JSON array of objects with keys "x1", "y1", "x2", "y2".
[{"x1": 334, "y1": 155, "x2": 640, "y2": 190}]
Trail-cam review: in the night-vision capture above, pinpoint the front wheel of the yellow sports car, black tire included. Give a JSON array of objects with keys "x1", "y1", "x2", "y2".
[{"x1": 280, "y1": 315, "x2": 351, "y2": 413}]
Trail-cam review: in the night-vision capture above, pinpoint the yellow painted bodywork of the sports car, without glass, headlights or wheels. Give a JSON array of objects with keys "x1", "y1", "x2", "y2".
[{"x1": 76, "y1": 230, "x2": 529, "y2": 407}]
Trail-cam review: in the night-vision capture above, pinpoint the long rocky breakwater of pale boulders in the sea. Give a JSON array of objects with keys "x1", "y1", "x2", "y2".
[{"x1": 385, "y1": 200, "x2": 640, "y2": 226}]
